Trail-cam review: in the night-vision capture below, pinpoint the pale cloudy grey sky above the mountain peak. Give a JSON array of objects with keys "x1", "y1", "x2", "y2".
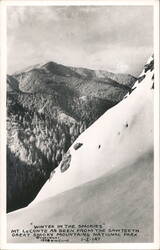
[{"x1": 7, "y1": 6, "x2": 153, "y2": 76}]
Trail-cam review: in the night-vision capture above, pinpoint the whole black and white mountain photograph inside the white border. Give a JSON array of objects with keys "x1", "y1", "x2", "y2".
[{"x1": 0, "y1": 0, "x2": 159, "y2": 249}]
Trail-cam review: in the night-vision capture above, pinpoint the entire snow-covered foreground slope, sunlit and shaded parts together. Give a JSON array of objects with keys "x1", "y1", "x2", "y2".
[{"x1": 7, "y1": 57, "x2": 154, "y2": 243}]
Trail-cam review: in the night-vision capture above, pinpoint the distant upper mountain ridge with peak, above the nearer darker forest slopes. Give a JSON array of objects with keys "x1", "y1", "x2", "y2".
[{"x1": 8, "y1": 62, "x2": 136, "y2": 101}]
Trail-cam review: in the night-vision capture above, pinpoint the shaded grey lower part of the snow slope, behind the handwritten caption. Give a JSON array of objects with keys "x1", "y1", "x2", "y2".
[{"x1": 7, "y1": 150, "x2": 153, "y2": 243}]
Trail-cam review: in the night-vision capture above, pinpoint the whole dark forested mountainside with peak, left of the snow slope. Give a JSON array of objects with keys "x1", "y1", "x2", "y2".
[{"x1": 7, "y1": 62, "x2": 136, "y2": 212}]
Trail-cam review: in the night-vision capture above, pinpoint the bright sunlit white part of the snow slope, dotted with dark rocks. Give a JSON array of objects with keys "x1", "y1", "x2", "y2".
[{"x1": 30, "y1": 57, "x2": 154, "y2": 206}]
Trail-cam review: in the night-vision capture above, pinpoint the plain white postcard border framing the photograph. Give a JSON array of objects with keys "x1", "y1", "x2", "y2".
[{"x1": 0, "y1": 0, "x2": 160, "y2": 250}]
